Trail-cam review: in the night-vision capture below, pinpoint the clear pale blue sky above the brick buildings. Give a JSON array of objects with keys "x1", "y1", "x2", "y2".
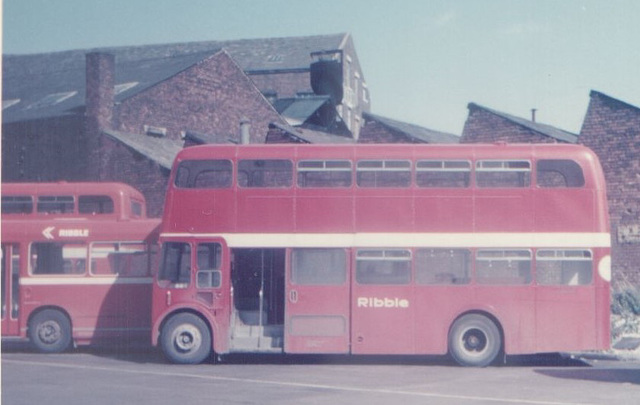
[{"x1": 3, "y1": 0, "x2": 640, "y2": 134}]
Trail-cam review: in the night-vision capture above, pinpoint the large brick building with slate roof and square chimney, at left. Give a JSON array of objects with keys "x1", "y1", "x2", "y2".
[{"x1": 2, "y1": 34, "x2": 376, "y2": 215}]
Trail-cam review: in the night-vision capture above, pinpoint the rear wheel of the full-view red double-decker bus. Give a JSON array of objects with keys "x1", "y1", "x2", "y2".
[{"x1": 449, "y1": 314, "x2": 502, "y2": 367}]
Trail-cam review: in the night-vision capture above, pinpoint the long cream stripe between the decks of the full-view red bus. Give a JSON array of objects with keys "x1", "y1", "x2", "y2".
[{"x1": 160, "y1": 232, "x2": 611, "y2": 248}]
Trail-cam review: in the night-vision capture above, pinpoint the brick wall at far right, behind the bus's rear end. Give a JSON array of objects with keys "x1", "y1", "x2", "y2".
[{"x1": 580, "y1": 91, "x2": 640, "y2": 284}]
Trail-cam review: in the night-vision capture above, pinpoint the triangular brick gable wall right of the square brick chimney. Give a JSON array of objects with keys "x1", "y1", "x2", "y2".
[{"x1": 114, "y1": 51, "x2": 282, "y2": 143}]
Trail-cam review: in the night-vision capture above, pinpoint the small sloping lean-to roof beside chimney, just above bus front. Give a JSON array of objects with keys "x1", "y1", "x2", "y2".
[{"x1": 102, "y1": 130, "x2": 182, "y2": 170}]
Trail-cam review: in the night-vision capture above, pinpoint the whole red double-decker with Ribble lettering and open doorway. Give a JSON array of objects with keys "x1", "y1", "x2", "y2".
[{"x1": 152, "y1": 144, "x2": 611, "y2": 366}]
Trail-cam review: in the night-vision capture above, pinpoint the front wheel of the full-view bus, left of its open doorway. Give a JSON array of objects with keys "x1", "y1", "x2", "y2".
[{"x1": 160, "y1": 313, "x2": 211, "y2": 364}]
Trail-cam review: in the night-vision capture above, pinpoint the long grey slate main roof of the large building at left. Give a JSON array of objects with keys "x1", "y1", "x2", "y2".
[{"x1": 2, "y1": 34, "x2": 349, "y2": 122}]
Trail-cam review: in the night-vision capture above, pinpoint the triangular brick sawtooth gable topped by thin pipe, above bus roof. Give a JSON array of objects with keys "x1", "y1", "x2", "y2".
[{"x1": 460, "y1": 106, "x2": 555, "y2": 143}]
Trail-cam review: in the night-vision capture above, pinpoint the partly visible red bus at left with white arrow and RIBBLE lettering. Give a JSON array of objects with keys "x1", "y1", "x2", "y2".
[{"x1": 2, "y1": 183, "x2": 160, "y2": 353}]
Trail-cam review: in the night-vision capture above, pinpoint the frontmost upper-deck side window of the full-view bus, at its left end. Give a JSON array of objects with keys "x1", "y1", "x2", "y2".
[{"x1": 175, "y1": 160, "x2": 233, "y2": 188}]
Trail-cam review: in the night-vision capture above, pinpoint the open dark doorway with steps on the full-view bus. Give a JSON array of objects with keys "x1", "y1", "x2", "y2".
[{"x1": 230, "y1": 249, "x2": 286, "y2": 352}]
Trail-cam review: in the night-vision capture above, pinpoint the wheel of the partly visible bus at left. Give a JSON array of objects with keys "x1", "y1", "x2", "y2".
[{"x1": 29, "y1": 309, "x2": 71, "y2": 353}]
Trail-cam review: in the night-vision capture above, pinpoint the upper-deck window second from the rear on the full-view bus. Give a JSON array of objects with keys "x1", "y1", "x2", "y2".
[{"x1": 476, "y1": 160, "x2": 531, "y2": 188}]
